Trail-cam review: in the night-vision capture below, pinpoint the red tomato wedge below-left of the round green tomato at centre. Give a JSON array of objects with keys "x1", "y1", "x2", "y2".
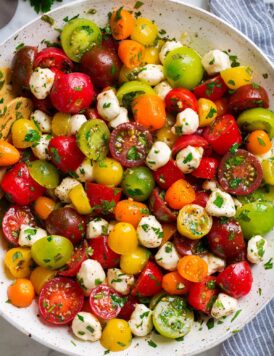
[{"x1": 86, "y1": 183, "x2": 122, "y2": 215}]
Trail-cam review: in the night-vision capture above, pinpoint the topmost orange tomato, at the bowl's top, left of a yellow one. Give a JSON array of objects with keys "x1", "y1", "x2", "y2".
[{"x1": 110, "y1": 8, "x2": 135, "y2": 40}]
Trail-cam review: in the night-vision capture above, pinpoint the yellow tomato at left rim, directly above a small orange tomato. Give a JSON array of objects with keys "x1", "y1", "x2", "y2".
[{"x1": 4, "y1": 247, "x2": 33, "y2": 278}]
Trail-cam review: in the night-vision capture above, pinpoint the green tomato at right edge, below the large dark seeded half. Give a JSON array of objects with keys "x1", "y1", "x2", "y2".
[{"x1": 236, "y1": 202, "x2": 274, "y2": 240}]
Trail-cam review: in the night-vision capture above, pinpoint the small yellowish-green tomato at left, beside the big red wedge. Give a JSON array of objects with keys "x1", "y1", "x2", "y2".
[{"x1": 28, "y1": 160, "x2": 60, "y2": 189}]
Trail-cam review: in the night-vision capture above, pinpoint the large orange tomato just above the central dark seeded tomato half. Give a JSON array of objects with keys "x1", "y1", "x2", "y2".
[{"x1": 132, "y1": 94, "x2": 166, "y2": 131}]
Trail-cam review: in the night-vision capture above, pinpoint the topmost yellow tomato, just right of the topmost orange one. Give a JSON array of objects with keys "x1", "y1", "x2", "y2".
[{"x1": 131, "y1": 17, "x2": 158, "y2": 46}]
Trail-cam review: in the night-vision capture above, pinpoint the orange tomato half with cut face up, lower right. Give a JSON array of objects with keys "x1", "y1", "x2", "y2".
[{"x1": 177, "y1": 255, "x2": 208, "y2": 283}]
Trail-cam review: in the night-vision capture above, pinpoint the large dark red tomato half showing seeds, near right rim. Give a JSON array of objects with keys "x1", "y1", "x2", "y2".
[{"x1": 218, "y1": 150, "x2": 263, "y2": 195}]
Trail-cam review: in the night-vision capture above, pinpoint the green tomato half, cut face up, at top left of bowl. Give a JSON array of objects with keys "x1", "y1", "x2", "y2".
[{"x1": 61, "y1": 18, "x2": 102, "y2": 62}]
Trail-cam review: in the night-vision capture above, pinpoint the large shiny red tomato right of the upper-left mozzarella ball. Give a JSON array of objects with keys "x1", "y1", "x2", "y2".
[{"x1": 50, "y1": 73, "x2": 94, "y2": 114}]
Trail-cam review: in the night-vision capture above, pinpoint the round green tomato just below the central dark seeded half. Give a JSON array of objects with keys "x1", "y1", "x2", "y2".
[{"x1": 121, "y1": 167, "x2": 155, "y2": 201}]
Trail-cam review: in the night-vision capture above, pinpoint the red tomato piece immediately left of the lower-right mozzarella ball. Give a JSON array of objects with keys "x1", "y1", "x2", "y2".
[{"x1": 188, "y1": 276, "x2": 218, "y2": 314}]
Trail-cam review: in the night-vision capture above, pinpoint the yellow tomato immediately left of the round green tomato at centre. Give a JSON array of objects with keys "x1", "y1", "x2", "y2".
[{"x1": 93, "y1": 158, "x2": 123, "y2": 187}]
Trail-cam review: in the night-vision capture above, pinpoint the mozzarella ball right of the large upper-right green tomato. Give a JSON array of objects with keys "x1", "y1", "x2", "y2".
[{"x1": 202, "y1": 49, "x2": 231, "y2": 75}]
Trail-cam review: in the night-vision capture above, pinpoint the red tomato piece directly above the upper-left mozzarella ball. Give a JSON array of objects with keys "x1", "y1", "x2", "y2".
[{"x1": 33, "y1": 47, "x2": 74, "y2": 73}]
